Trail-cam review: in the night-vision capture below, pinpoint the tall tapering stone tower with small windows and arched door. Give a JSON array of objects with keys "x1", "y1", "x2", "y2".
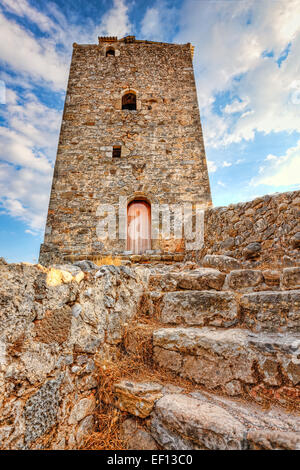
[{"x1": 40, "y1": 36, "x2": 211, "y2": 264}]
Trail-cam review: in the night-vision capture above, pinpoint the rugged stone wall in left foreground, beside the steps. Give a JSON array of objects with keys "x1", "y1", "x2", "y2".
[{"x1": 0, "y1": 264, "x2": 142, "y2": 449}]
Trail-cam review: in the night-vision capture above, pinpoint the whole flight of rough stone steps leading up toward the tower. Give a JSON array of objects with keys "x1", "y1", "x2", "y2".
[{"x1": 110, "y1": 257, "x2": 300, "y2": 450}]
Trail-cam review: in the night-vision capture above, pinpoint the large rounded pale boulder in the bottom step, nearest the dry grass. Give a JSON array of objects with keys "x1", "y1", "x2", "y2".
[{"x1": 151, "y1": 394, "x2": 246, "y2": 450}]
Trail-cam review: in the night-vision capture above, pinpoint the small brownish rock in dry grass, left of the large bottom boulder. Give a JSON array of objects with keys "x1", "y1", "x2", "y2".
[{"x1": 121, "y1": 418, "x2": 158, "y2": 450}]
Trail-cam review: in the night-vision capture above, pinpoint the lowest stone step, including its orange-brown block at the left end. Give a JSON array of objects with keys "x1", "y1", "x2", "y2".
[{"x1": 111, "y1": 379, "x2": 300, "y2": 450}]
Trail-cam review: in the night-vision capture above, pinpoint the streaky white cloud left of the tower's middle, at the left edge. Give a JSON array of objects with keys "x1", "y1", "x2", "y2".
[{"x1": 0, "y1": 90, "x2": 61, "y2": 231}]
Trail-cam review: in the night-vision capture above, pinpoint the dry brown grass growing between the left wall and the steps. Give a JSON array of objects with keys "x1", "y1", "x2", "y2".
[{"x1": 83, "y1": 317, "x2": 204, "y2": 450}]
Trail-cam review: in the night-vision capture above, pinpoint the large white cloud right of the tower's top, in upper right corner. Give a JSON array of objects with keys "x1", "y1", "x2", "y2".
[{"x1": 176, "y1": 0, "x2": 300, "y2": 148}]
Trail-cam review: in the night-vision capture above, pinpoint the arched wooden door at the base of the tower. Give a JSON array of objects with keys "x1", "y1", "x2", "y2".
[{"x1": 127, "y1": 201, "x2": 151, "y2": 254}]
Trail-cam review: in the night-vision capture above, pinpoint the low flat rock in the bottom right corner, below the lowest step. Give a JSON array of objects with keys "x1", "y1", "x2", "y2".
[{"x1": 247, "y1": 429, "x2": 300, "y2": 450}]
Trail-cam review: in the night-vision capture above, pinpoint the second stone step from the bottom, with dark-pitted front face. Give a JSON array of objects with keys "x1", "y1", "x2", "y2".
[{"x1": 153, "y1": 327, "x2": 300, "y2": 407}]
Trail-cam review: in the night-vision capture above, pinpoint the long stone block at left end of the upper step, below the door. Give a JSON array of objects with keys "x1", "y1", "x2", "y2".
[{"x1": 148, "y1": 268, "x2": 225, "y2": 292}]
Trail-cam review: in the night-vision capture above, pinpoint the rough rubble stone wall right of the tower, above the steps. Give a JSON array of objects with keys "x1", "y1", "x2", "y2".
[{"x1": 201, "y1": 191, "x2": 300, "y2": 266}]
